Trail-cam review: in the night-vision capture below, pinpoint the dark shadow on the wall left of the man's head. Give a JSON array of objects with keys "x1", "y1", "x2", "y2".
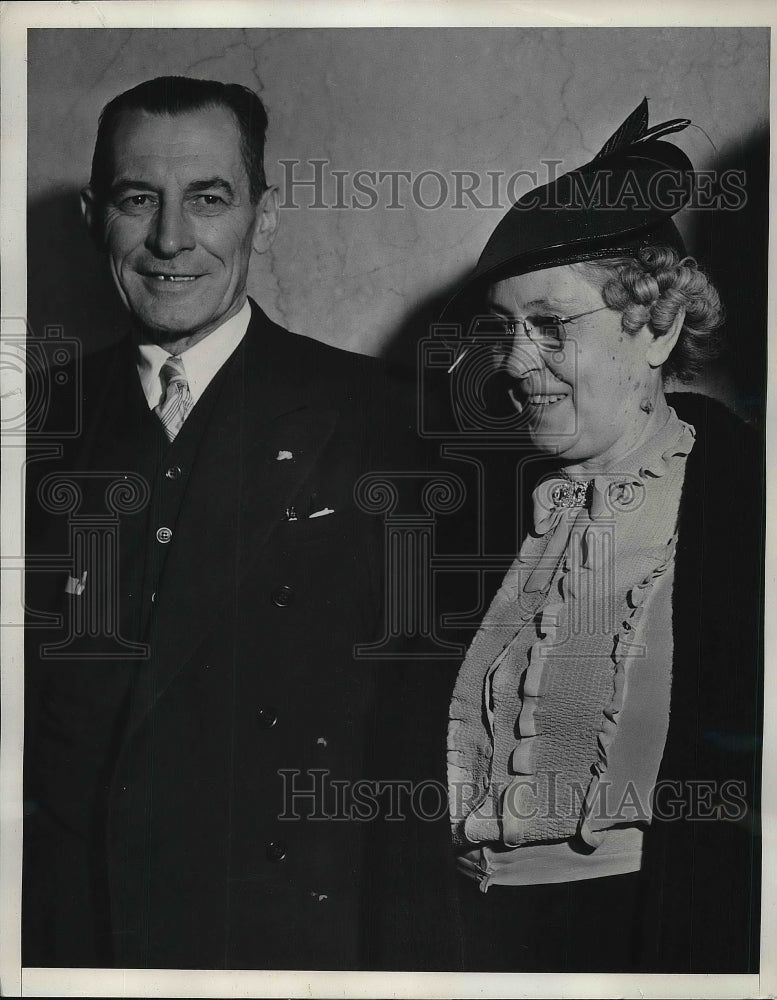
[{"x1": 27, "y1": 187, "x2": 127, "y2": 354}]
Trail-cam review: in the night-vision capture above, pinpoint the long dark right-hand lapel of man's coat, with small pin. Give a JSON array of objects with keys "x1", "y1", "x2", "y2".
[{"x1": 124, "y1": 307, "x2": 338, "y2": 728}]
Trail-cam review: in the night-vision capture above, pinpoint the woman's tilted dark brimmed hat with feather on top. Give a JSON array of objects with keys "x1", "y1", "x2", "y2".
[{"x1": 444, "y1": 98, "x2": 693, "y2": 315}]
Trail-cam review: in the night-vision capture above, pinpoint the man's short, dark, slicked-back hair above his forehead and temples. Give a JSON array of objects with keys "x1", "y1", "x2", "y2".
[{"x1": 90, "y1": 76, "x2": 267, "y2": 204}]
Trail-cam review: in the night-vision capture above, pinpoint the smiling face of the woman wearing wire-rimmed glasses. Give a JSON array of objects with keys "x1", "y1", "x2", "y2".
[{"x1": 488, "y1": 264, "x2": 662, "y2": 470}]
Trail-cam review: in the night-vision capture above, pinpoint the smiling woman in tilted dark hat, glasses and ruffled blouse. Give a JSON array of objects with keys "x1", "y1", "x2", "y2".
[{"x1": 440, "y1": 102, "x2": 763, "y2": 972}]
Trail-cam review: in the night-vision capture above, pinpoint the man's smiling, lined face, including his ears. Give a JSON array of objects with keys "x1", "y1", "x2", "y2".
[{"x1": 84, "y1": 107, "x2": 277, "y2": 346}]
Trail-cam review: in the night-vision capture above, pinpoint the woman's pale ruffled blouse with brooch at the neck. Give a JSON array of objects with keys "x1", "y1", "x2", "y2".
[{"x1": 448, "y1": 410, "x2": 694, "y2": 884}]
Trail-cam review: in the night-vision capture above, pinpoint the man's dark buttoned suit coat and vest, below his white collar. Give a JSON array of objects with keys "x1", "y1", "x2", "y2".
[{"x1": 23, "y1": 303, "x2": 400, "y2": 969}]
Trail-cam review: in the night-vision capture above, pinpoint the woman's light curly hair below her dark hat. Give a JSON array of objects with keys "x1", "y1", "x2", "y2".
[{"x1": 572, "y1": 246, "x2": 723, "y2": 382}]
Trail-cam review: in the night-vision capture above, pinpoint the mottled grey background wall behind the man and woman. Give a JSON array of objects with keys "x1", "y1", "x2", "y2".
[{"x1": 29, "y1": 28, "x2": 769, "y2": 415}]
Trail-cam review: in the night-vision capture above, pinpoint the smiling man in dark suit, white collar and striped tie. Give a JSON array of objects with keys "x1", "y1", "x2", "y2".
[{"x1": 23, "y1": 77, "x2": 400, "y2": 969}]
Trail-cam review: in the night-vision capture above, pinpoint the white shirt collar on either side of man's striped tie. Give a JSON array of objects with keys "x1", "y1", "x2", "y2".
[{"x1": 137, "y1": 299, "x2": 251, "y2": 409}]
